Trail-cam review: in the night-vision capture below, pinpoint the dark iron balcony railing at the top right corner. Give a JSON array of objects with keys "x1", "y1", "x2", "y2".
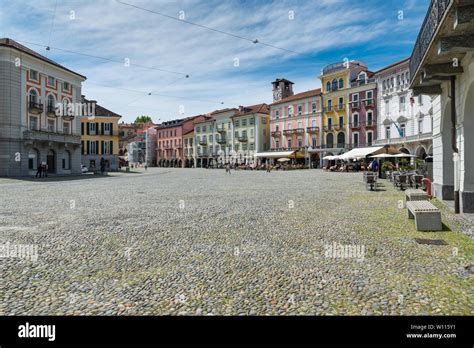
[{"x1": 410, "y1": 0, "x2": 454, "y2": 81}]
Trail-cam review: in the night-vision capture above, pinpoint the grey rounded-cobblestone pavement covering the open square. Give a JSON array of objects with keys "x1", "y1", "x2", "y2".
[{"x1": 0, "y1": 168, "x2": 474, "y2": 315}]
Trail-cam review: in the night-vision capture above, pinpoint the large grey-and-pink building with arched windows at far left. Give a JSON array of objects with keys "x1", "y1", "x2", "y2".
[{"x1": 0, "y1": 39, "x2": 86, "y2": 176}]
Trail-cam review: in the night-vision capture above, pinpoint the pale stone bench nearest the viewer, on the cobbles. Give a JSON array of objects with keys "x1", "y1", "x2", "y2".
[{"x1": 407, "y1": 201, "x2": 443, "y2": 231}]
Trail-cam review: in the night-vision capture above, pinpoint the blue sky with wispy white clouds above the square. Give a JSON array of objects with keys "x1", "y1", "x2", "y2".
[{"x1": 0, "y1": 0, "x2": 429, "y2": 122}]
